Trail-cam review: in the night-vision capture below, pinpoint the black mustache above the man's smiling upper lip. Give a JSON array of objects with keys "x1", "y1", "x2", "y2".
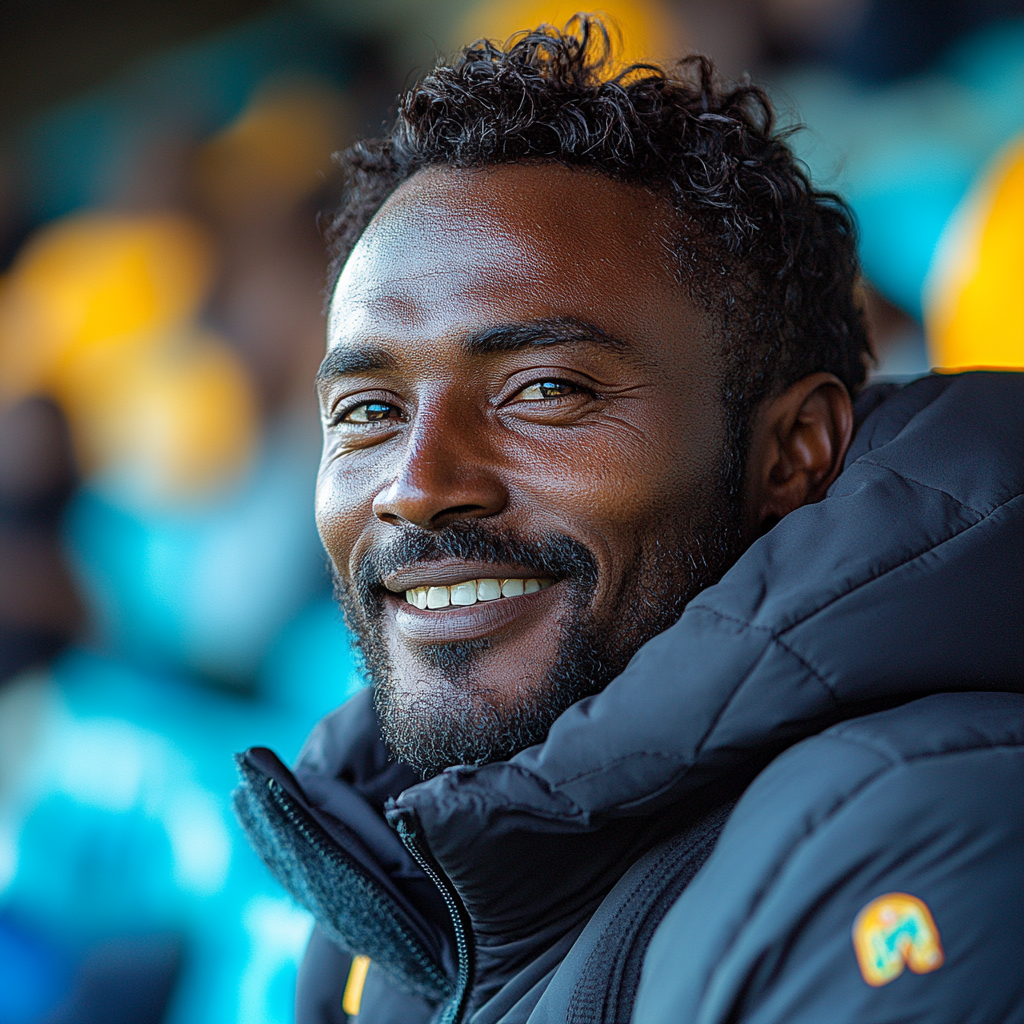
[{"x1": 345, "y1": 520, "x2": 598, "y2": 613}]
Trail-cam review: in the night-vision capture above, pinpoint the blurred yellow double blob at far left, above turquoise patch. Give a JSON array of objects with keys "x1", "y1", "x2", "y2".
[{"x1": 0, "y1": 213, "x2": 258, "y2": 504}]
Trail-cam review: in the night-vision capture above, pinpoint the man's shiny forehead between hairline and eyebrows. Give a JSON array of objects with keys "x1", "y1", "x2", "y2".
[{"x1": 328, "y1": 164, "x2": 692, "y2": 348}]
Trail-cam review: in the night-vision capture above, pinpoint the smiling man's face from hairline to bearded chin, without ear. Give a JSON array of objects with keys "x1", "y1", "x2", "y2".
[{"x1": 316, "y1": 164, "x2": 738, "y2": 774}]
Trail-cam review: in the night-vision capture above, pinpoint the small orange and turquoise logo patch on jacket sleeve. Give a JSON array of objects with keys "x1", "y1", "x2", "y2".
[{"x1": 853, "y1": 893, "x2": 945, "y2": 986}]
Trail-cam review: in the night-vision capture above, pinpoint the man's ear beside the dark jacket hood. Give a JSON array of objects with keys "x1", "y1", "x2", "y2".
[{"x1": 744, "y1": 373, "x2": 853, "y2": 537}]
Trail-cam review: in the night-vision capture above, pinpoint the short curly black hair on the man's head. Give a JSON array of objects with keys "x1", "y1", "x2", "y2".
[{"x1": 326, "y1": 15, "x2": 870, "y2": 477}]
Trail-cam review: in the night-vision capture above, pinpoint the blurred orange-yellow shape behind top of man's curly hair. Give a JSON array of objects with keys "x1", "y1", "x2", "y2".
[{"x1": 455, "y1": 0, "x2": 686, "y2": 63}]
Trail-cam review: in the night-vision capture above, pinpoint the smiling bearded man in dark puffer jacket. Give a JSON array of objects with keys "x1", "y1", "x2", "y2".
[{"x1": 237, "y1": 20, "x2": 1024, "y2": 1024}]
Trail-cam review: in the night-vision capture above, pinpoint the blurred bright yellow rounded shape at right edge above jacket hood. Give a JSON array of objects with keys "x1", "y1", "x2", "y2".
[{"x1": 924, "y1": 138, "x2": 1024, "y2": 370}]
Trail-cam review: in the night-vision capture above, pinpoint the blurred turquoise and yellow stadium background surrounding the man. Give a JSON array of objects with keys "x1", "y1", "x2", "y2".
[{"x1": 0, "y1": 0, "x2": 1024, "y2": 1024}]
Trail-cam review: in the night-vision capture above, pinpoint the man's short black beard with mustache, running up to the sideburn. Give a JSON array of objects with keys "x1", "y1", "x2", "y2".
[{"x1": 332, "y1": 458, "x2": 742, "y2": 778}]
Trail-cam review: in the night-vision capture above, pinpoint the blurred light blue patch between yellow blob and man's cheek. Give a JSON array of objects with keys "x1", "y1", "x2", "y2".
[{"x1": 67, "y1": 415, "x2": 327, "y2": 683}]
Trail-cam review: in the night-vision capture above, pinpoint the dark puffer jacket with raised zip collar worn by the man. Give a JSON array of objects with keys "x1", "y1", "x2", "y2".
[{"x1": 237, "y1": 374, "x2": 1024, "y2": 1024}]
